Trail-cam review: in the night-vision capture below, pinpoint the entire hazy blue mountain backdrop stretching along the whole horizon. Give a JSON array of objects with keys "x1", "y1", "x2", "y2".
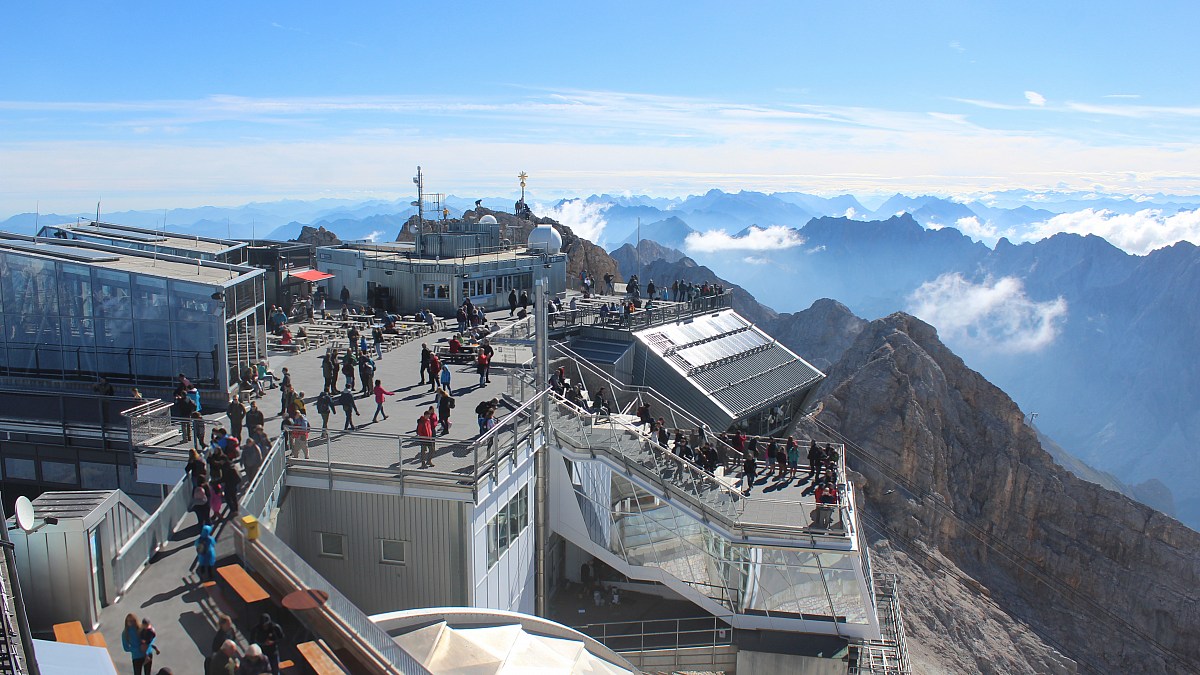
[{"x1": 0, "y1": 190, "x2": 1200, "y2": 526}]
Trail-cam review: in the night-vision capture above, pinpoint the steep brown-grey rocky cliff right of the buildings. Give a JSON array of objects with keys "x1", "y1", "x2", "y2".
[{"x1": 796, "y1": 313, "x2": 1200, "y2": 673}]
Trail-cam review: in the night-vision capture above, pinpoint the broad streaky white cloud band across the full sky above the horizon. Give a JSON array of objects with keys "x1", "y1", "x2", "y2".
[{"x1": 7, "y1": 90, "x2": 1200, "y2": 215}]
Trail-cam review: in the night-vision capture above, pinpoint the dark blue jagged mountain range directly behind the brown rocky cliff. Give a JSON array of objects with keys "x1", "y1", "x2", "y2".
[{"x1": 618, "y1": 212, "x2": 1200, "y2": 527}]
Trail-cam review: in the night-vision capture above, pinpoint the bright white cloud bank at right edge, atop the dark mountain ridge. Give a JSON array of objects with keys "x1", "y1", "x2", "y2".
[{"x1": 1022, "y1": 209, "x2": 1200, "y2": 256}]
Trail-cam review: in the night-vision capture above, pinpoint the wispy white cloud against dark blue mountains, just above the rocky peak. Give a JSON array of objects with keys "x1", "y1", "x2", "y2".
[{"x1": 908, "y1": 273, "x2": 1067, "y2": 353}]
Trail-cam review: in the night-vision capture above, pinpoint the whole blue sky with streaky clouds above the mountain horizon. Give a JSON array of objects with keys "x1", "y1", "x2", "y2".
[{"x1": 0, "y1": 1, "x2": 1200, "y2": 217}]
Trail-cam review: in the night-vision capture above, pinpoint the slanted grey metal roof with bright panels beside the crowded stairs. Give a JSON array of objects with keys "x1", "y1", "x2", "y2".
[{"x1": 634, "y1": 310, "x2": 824, "y2": 418}]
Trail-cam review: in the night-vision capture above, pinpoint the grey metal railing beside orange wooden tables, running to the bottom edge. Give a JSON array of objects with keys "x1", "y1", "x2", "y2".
[{"x1": 234, "y1": 527, "x2": 430, "y2": 675}]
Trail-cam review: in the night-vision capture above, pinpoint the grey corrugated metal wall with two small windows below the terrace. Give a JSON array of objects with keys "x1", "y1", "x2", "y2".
[{"x1": 276, "y1": 488, "x2": 470, "y2": 614}]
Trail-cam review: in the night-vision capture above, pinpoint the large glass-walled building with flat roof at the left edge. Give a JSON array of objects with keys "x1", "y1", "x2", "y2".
[{"x1": 0, "y1": 234, "x2": 265, "y2": 400}]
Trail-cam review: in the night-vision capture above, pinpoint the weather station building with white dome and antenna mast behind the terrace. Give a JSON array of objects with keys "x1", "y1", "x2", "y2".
[{"x1": 317, "y1": 173, "x2": 566, "y2": 316}]
